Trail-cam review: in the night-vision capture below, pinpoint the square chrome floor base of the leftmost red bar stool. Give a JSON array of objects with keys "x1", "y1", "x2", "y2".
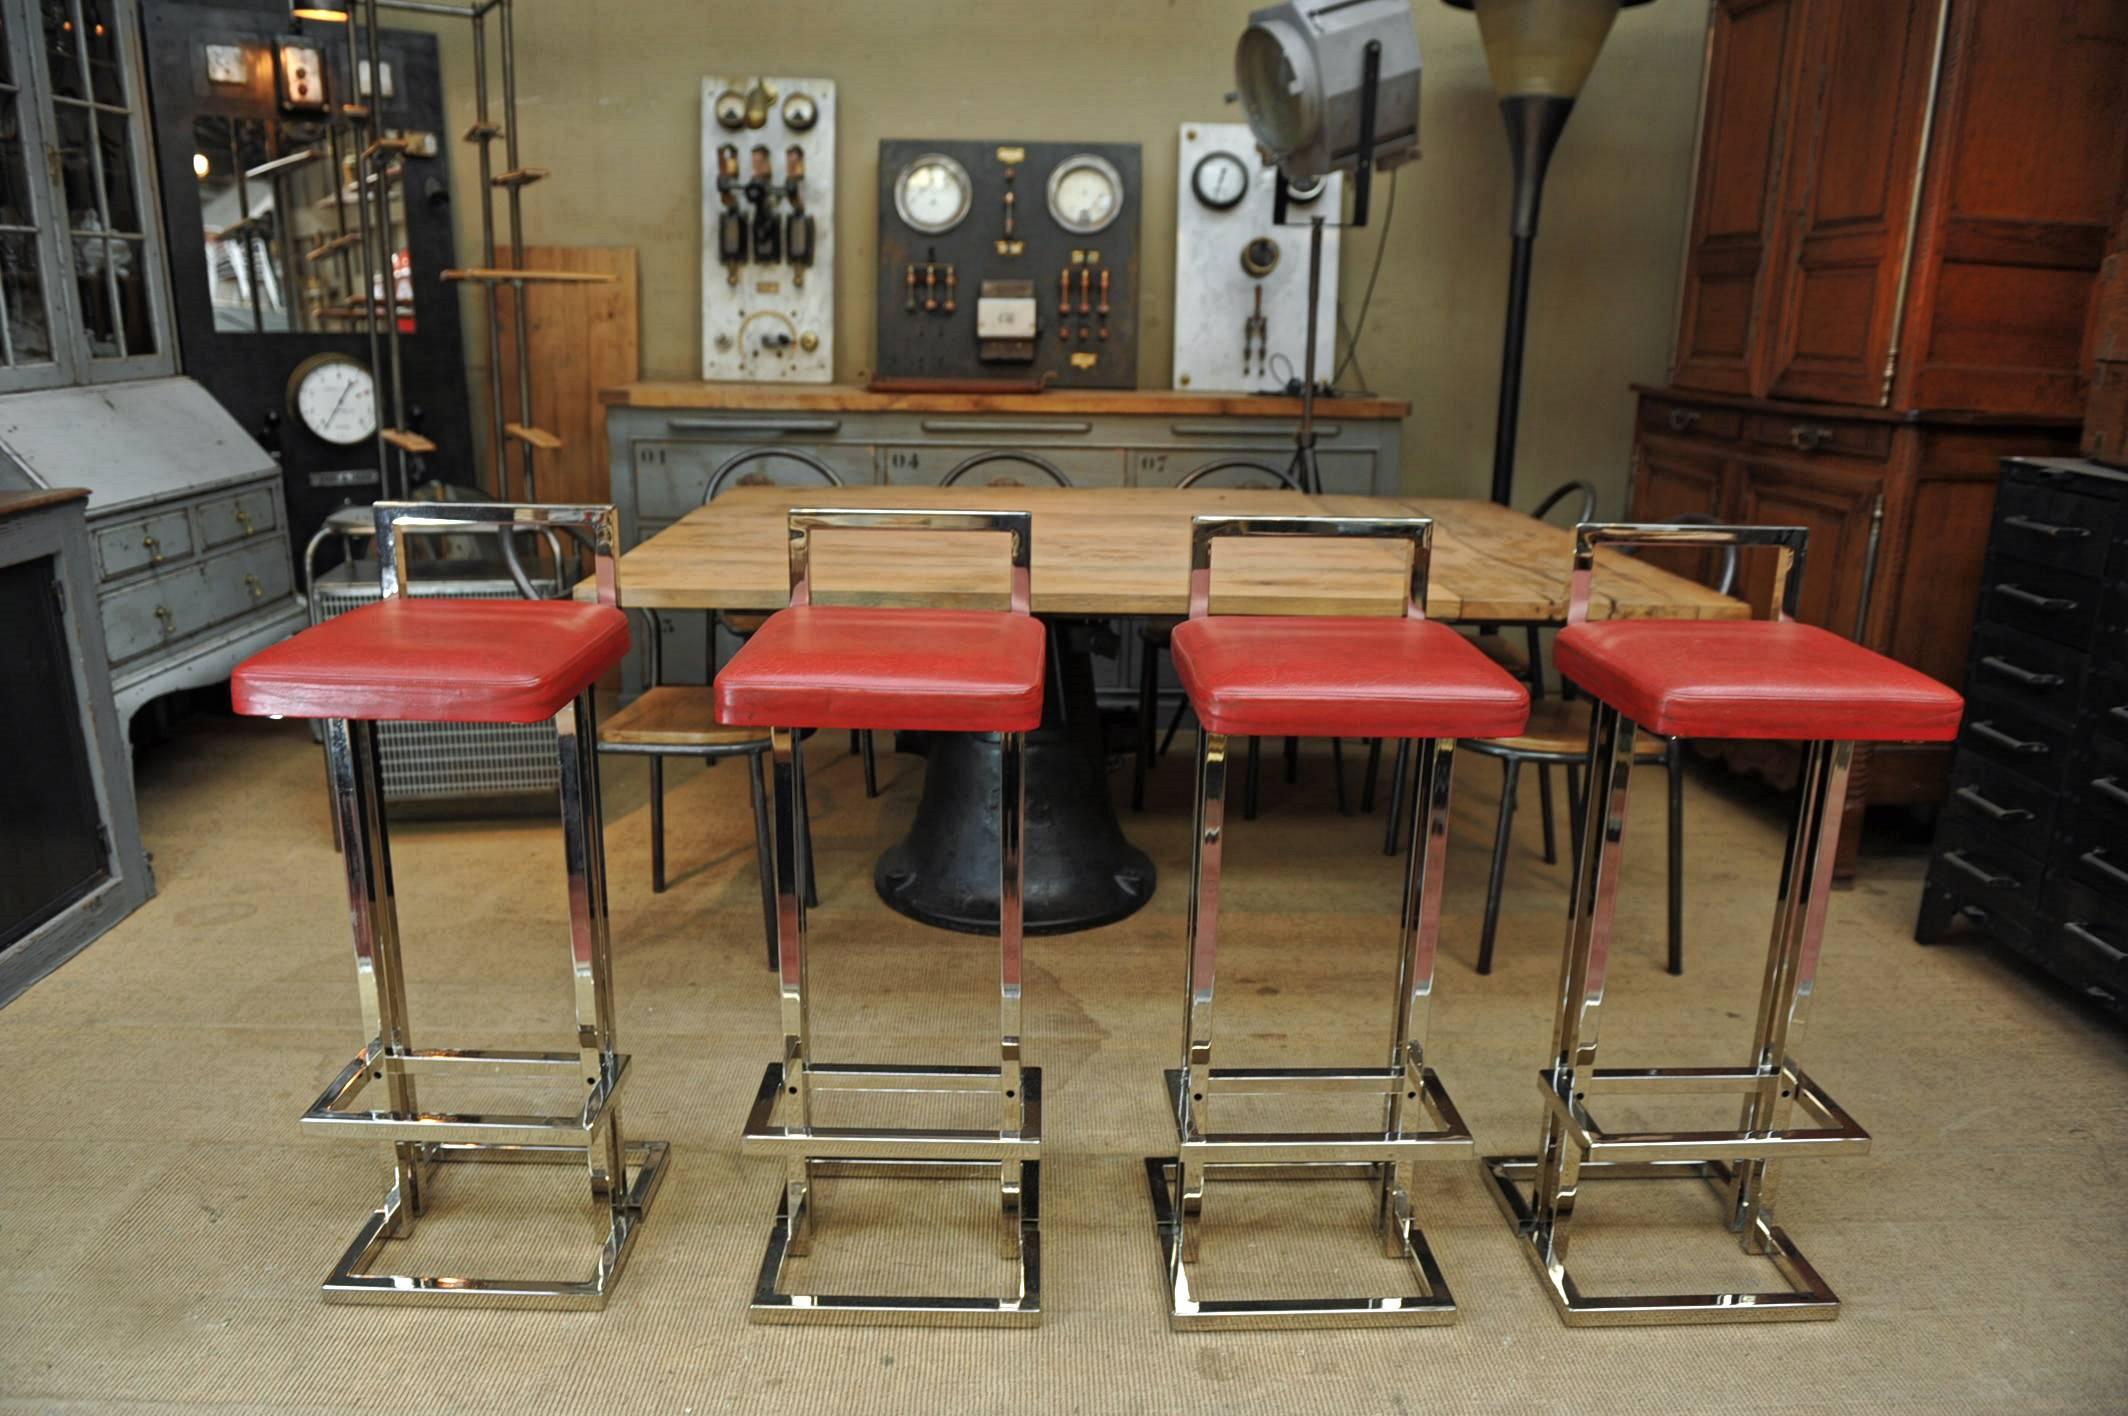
[{"x1": 323, "y1": 1141, "x2": 670, "y2": 1307}]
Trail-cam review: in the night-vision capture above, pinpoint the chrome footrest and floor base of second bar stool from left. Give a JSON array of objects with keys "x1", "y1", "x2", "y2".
[{"x1": 743, "y1": 1063, "x2": 1043, "y2": 1327}]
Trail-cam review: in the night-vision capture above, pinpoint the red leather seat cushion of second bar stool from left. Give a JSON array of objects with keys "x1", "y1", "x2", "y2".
[{"x1": 717, "y1": 605, "x2": 1049, "y2": 732}]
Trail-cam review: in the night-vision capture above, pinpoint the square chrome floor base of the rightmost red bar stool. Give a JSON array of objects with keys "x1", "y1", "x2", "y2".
[{"x1": 1485, "y1": 1156, "x2": 1841, "y2": 1327}]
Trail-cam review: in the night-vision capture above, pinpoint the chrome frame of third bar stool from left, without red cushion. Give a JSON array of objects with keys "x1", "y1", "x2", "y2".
[{"x1": 1145, "y1": 515, "x2": 1473, "y2": 1331}]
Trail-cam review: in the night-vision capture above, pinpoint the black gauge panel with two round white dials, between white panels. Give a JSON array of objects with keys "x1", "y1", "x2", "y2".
[{"x1": 872, "y1": 138, "x2": 1143, "y2": 388}]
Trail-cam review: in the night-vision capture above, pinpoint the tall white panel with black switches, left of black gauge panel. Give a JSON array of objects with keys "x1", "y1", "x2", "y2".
[{"x1": 702, "y1": 75, "x2": 834, "y2": 383}]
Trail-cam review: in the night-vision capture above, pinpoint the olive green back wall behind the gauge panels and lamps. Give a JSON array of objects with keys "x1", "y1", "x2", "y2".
[{"x1": 392, "y1": 0, "x2": 1705, "y2": 511}]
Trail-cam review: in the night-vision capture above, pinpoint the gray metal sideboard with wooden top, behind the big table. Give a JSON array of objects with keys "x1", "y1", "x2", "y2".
[{"x1": 600, "y1": 381, "x2": 1411, "y2": 701}]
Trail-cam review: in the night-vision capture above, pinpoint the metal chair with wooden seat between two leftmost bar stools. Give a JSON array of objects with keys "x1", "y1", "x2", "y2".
[{"x1": 598, "y1": 611, "x2": 819, "y2": 969}]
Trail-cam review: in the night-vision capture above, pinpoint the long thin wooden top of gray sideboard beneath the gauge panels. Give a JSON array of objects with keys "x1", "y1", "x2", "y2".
[{"x1": 598, "y1": 379, "x2": 1411, "y2": 422}]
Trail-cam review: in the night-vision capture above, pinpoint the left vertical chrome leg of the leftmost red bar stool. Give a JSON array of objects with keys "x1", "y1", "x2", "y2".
[{"x1": 326, "y1": 718, "x2": 423, "y2": 1237}]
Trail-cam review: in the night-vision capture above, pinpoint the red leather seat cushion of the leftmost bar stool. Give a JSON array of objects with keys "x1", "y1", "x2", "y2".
[{"x1": 230, "y1": 598, "x2": 628, "y2": 722}]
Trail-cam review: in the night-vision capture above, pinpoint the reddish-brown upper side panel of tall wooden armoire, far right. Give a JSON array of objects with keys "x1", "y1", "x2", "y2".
[{"x1": 1894, "y1": 0, "x2": 2128, "y2": 417}]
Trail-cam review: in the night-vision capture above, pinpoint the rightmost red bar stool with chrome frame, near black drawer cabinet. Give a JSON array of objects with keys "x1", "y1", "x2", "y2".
[{"x1": 1485, "y1": 524, "x2": 1964, "y2": 1327}]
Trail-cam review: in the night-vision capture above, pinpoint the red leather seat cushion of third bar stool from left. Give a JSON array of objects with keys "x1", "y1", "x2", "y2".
[{"x1": 1173, "y1": 615, "x2": 1530, "y2": 737}]
